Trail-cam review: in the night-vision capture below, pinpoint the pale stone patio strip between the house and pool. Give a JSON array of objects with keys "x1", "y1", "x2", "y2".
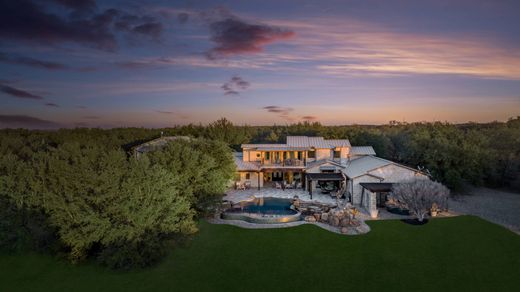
[{"x1": 223, "y1": 188, "x2": 336, "y2": 205}]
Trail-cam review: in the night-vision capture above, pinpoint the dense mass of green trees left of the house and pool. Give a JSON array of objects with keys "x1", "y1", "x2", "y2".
[{"x1": 0, "y1": 136, "x2": 234, "y2": 268}]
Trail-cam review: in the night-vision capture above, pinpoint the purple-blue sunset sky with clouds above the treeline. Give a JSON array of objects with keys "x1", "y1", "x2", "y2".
[{"x1": 0, "y1": 0, "x2": 520, "y2": 128}]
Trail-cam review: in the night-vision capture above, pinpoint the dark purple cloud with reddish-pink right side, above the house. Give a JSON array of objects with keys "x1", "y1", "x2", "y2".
[{"x1": 208, "y1": 14, "x2": 295, "y2": 58}]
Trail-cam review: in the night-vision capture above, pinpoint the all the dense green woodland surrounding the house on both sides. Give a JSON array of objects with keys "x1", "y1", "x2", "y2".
[{"x1": 0, "y1": 117, "x2": 520, "y2": 268}]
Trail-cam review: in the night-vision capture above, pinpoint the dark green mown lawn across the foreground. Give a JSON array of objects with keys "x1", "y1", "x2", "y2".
[{"x1": 0, "y1": 216, "x2": 520, "y2": 291}]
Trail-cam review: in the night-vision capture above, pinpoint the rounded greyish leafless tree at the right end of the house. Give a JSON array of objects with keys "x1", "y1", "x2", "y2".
[{"x1": 392, "y1": 179, "x2": 450, "y2": 222}]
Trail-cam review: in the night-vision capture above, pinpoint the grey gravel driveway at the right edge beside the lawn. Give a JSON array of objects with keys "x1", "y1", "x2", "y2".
[{"x1": 449, "y1": 187, "x2": 520, "y2": 234}]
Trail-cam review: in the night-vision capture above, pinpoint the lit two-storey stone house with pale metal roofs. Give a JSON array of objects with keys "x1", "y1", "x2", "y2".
[{"x1": 235, "y1": 136, "x2": 428, "y2": 217}]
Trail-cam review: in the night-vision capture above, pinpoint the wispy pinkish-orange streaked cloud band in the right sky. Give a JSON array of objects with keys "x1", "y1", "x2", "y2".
[{"x1": 271, "y1": 19, "x2": 520, "y2": 79}]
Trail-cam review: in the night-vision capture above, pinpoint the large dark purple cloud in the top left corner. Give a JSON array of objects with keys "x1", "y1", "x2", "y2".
[{"x1": 0, "y1": 0, "x2": 162, "y2": 51}]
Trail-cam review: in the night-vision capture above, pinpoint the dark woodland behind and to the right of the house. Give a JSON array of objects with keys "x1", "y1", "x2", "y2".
[{"x1": 172, "y1": 117, "x2": 520, "y2": 190}]
